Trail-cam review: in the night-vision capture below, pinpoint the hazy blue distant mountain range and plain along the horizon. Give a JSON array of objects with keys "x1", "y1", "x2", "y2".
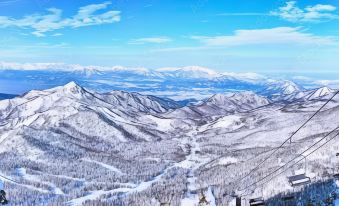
[{"x1": 0, "y1": 63, "x2": 334, "y2": 103}]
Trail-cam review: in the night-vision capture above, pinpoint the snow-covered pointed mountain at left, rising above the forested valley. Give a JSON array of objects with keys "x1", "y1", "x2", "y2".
[{"x1": 0, "y1": 82, "x2": 186, "y2": 144}]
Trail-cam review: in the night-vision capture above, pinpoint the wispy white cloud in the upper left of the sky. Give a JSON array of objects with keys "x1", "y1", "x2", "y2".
[{"x1": 0, "y1": 2, "x2": 120, "y2": 37}]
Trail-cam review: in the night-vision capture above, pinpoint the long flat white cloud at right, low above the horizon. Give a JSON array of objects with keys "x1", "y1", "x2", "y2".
[{"x1": 191, "y1": 27, "x2": 338, "y2": 46}]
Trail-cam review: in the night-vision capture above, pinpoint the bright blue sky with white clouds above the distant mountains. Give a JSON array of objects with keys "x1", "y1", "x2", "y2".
[{"x1": 0, "y1": 0, "x2": 339, "y2": 74}]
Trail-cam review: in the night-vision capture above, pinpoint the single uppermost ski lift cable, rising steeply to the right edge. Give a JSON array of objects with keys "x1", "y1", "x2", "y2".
[{"x1": 235, "y1": 90, "x2": 339, "y2": 187}]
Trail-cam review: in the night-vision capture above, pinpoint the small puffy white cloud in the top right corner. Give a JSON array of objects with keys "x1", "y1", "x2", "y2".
[{"x1": 270, "y1": 1, "x2": 339, "y2": 22}]
